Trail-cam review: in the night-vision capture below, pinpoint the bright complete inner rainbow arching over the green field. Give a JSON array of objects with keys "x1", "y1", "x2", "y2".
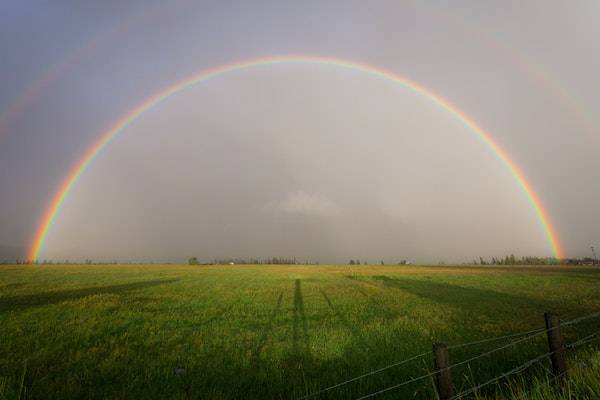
[{"x1": 28, "y1": 55, "x2": 563, "y2": 261}]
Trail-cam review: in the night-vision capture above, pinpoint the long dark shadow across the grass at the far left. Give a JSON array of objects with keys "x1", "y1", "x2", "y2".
[{"x1": 0, "y1": 279, "x2": 177, "y2": 312}]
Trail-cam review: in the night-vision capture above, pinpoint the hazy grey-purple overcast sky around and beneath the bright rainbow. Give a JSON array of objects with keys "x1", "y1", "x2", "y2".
[{"x1": 0, "y1": 0, "x2": 600, "y2": 263}]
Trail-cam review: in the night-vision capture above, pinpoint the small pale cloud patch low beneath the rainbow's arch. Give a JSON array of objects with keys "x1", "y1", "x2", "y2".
[{"x1": 265, "y1": 190, "x2": 340, "y2": 217}]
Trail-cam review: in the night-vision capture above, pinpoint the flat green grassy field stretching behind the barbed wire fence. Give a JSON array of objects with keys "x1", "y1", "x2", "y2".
[{"x1": 0, "y1": 265, "x2": 600, "y2": 399}]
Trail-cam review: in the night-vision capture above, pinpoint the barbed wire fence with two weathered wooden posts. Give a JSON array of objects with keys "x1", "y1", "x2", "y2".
[{"x1": 297, "y1": 311, "x2": 600, "y2": 400}]
